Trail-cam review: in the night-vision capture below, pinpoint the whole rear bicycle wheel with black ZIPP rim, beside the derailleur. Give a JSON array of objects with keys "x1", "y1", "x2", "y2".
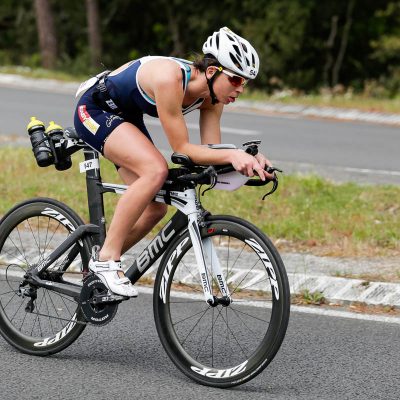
[{"x1": 0, "y1": 198, "x2": 90, "y2": 356}]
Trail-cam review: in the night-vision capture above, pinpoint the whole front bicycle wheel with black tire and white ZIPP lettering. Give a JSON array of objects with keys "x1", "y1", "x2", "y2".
[{"x1": 153, "y1": 215, "x2": 290, "y2": 388}]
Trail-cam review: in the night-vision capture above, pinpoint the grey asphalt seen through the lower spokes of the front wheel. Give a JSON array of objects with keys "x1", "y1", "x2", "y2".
[{"x1": 171, "y1": 297, "x2": 270, "y2": 368}]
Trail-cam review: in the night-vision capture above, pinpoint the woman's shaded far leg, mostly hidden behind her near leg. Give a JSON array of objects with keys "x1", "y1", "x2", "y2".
[{"x1": 118, "y1": 168, "x2": 168, "y2": 254}]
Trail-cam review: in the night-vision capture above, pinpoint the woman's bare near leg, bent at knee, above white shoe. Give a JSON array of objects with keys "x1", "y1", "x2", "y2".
[{"x1": 99, "y1": 122, "x2": 168, "y2": 261}]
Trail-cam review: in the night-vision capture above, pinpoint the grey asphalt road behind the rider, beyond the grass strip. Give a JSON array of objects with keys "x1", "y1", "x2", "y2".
[{"x1": 0, "y1": 87, "x2": 400, "y2": 184}]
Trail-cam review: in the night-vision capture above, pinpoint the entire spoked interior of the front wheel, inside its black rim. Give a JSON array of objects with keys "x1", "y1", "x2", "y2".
[{"x1": 169, "y1": 230, "x2": 273, "y2": 369}]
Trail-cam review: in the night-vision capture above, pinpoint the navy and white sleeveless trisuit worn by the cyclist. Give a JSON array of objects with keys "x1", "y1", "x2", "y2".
[{"x1": 74, "y1": 56, "x2": 204, "y2": 154}]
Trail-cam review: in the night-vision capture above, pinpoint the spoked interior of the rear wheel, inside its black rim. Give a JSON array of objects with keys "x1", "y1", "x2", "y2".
[{"x1": 0, "y1": 215, "x2": 81, "y2": 338}]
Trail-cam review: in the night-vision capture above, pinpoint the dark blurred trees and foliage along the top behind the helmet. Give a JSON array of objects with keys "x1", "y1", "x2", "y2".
[{"x1": 0, "y1": 0, "x2": 400, "y2": 98}]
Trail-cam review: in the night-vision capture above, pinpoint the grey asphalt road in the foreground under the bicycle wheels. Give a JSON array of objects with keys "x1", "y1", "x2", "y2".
[{"x1": 0, "y1": 294, "x2": 400, "y2": 400}]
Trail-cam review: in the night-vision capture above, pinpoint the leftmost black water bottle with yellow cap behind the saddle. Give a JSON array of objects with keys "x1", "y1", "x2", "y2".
[{"x1": 26, "y1": 117, "x2": 54, "y2": 167}]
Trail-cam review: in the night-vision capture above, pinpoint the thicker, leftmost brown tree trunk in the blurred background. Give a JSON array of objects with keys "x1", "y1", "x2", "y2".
[{"x1": 35, "y1": 0, "x2": 58, "y2": 68}]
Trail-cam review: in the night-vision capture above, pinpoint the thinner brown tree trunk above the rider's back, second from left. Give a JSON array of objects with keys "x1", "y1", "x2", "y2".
[{"x1": 86, "y1": 0, "x2": 102, "y2": 68}]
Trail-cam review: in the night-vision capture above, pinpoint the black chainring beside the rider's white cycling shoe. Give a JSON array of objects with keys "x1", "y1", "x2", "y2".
[{"x1": 80, "y1": 274, "x2": 118, "y2": 326}]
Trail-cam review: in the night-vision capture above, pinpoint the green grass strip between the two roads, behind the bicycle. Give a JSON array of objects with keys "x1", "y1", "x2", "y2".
[{"x1": 0, "y1": 147, "x2": 400, "y2": 257}]
